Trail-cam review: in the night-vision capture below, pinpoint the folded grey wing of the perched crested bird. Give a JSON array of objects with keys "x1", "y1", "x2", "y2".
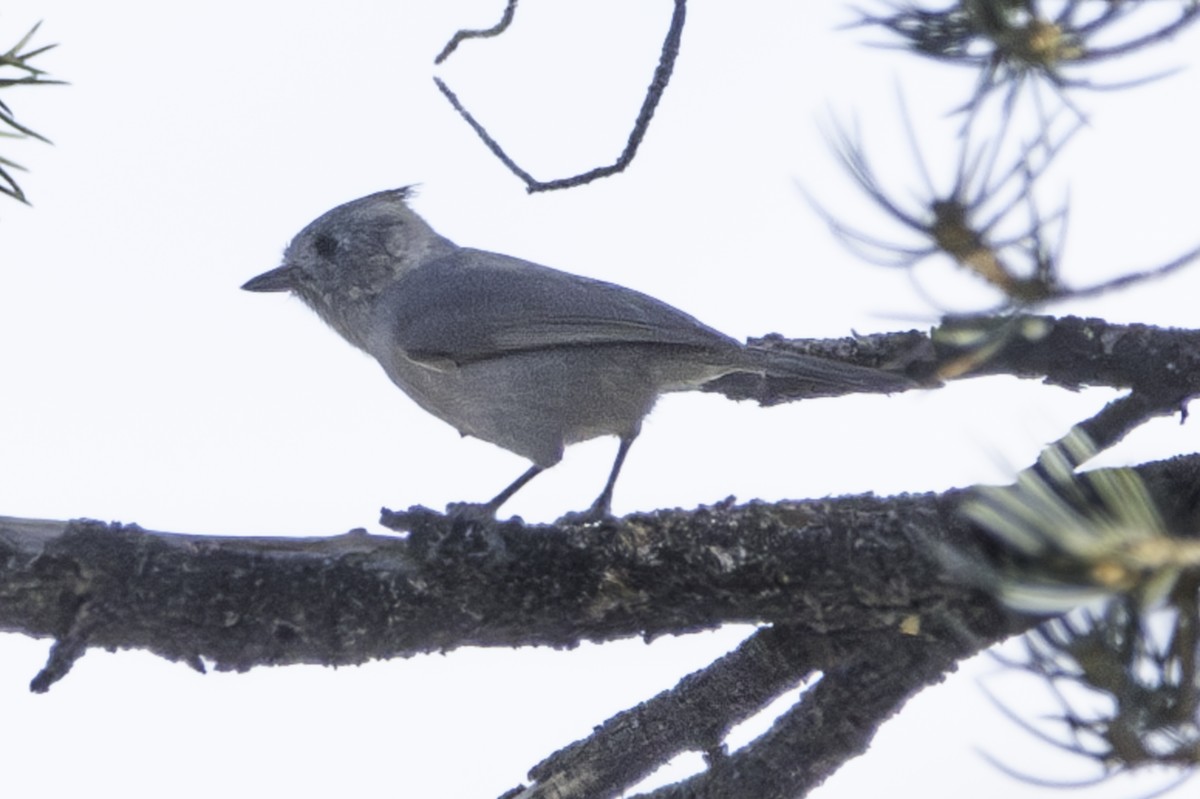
[{"x1": 377, "y1": 250, "x2": 739, "y2": 364}]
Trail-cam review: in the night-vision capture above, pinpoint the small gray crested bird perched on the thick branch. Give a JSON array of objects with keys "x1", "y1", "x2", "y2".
[{"x1": 242, "y1": 187, "x2": 913, "y2": 519}]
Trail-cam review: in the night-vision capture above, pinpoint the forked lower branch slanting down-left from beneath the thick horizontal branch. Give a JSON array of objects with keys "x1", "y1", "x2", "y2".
[{"x1": 506, "y1": 613, "x2": 993, "y2": 799}]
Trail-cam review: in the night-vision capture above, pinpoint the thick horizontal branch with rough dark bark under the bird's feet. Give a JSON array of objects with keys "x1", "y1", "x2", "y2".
[{"x1": 0, "y1": 484, "x2": 988, "y2": 691}]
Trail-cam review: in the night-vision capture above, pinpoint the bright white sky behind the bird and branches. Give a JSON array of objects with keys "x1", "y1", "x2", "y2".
[{"x1": 0, "y1": 0, "x2": 1200, "y2": 799}]
